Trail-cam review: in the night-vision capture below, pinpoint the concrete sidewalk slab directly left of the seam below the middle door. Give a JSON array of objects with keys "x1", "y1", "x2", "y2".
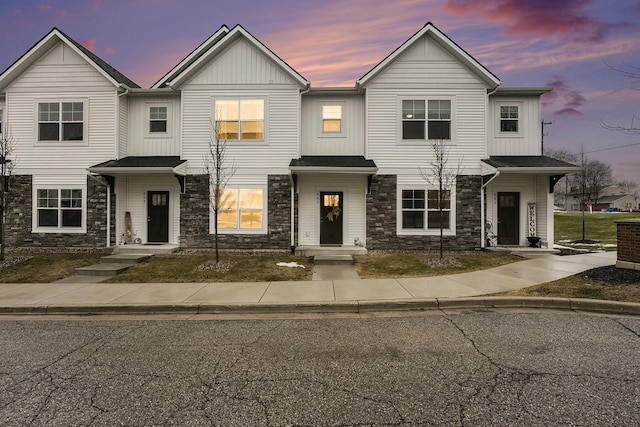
[{"x1": 260, "y1": 280, "x2": 335, "y2": 303}]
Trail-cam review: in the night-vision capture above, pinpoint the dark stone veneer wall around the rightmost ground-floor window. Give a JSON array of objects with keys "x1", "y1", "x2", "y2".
[{"x1": 367, "y1": 175, "x2": 482, "y2": 251}]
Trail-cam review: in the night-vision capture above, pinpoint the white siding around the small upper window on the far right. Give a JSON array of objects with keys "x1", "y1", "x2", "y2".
[{"x1": 487, "y1": 96, "x2": 542, "y2": 156}]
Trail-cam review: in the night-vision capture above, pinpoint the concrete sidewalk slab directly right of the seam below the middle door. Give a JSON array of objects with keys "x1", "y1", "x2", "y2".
[{"x1": 333, "y1": 279, "x2": 411, "y2": 301}]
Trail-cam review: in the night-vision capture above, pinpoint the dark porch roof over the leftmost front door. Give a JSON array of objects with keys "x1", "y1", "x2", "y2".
[{"x1": 87, "y1": 156, "x2": 187, "y2": 176}]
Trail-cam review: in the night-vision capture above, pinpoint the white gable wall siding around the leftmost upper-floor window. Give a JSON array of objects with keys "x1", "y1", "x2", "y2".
[{"x1": 5, "y1": 43, "x2": 118, "y2": 174}]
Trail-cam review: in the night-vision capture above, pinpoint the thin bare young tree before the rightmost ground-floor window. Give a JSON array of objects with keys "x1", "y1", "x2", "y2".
[{"x1": 420, "y1": 139, "x2": 462, "y2": 259}]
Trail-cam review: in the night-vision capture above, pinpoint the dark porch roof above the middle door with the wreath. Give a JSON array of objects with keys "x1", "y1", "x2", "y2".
[{"x1": 289, "y1": 156, "x2": 378, "y2": 174}]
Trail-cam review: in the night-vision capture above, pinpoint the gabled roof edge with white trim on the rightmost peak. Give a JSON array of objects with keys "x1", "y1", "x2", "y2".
[{"x1": 356, "y1": 22, "x2": 501, "y2": 88}]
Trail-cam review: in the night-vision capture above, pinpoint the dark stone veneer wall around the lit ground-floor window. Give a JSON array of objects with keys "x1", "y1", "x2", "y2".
[{"x1": 180, "y1": 175, "x2": 291, "y2": 250}]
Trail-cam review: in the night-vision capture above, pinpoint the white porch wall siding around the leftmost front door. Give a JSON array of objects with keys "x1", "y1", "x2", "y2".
[{"x1": 115, "y1": 174, "x2": 180, "y2": 244}]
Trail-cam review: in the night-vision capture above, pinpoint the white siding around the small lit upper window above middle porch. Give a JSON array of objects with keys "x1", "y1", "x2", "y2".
[{"x1": 301, "y1": 95, "x2": 365, "y2": 156}]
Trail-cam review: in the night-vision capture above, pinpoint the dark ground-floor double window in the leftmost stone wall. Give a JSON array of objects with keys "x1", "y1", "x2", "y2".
[{"x1": 36, "y1": 188, "x2": 83, "y2": 231}]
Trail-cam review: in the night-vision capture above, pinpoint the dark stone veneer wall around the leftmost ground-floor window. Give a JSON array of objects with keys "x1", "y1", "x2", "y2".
[{"x1": 5, "y1": 175, "x2": 116, "y2": 247}]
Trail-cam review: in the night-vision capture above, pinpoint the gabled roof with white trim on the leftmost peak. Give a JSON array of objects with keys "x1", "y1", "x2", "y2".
[{"x1": 0, "y1": 27, "x2": 140, "y2": 89}]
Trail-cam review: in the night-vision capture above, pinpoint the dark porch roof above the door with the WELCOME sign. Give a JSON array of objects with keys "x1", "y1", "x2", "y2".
[{"x1": 481, "y1": 156, "x2": 582, "y2": 175}]
